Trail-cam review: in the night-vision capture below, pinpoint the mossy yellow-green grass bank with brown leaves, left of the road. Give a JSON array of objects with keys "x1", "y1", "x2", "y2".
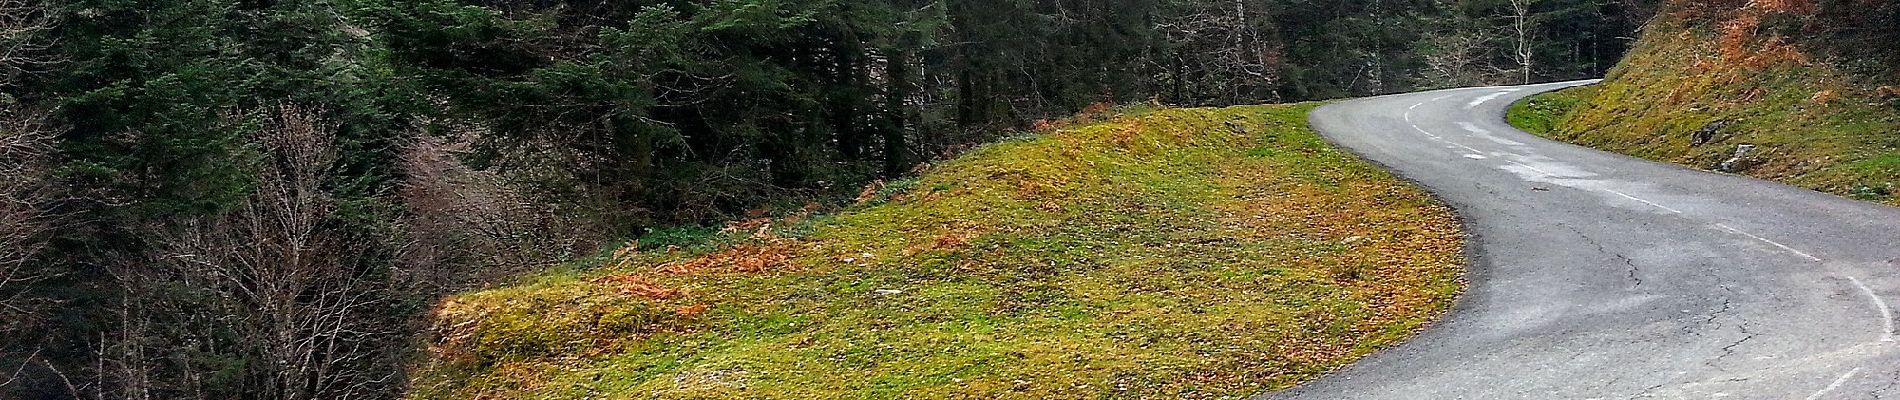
[{"x1": 409, "y1": 104, "x2": 1463, "y2": 398}]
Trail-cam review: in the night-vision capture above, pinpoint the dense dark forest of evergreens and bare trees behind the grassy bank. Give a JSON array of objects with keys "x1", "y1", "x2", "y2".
[{"x1": 0, "y1": 0, "x2": 1657, "y2": 398}]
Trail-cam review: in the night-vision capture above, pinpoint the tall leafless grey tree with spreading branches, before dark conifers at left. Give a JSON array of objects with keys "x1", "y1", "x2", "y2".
[{"x1": 105, "y1": 106, "x2": 401, "y2": 400}]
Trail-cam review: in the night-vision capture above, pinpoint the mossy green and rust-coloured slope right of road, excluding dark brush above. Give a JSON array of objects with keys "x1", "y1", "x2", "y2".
[{"x1": 1511, "y1": 21, "x2": 1900, "y2": 205}]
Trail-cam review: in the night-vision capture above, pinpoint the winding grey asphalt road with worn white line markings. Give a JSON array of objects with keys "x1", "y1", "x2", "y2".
[{"x1": 1264, "y1": 82, "x2": 1900, "y2": 400}]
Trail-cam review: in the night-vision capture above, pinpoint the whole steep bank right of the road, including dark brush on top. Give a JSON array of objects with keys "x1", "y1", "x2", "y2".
[{"x1": 1511, "y1": 0, "x2": 1900, "y2": 205}]
